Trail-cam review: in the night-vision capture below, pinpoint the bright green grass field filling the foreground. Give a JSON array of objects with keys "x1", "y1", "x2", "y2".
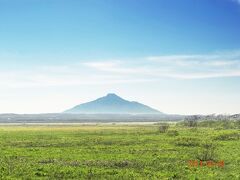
[{"x1": 0, "y1": 124, "x2": 240, "y2": 179}]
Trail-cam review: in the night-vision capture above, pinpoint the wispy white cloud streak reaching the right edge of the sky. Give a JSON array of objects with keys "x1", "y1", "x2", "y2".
[{"x1": 85, "y1": 52, "x2": 240, "y2": 79}]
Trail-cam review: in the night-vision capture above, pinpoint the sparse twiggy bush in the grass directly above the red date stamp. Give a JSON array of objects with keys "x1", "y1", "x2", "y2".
[{"x1": 196, "y1": 142, "x2": 217, "y2": 161}]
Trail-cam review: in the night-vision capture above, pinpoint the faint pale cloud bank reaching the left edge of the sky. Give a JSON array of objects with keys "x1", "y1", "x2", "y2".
[{"x1": 0, "y1": 63, "x2": 152, "y2": 89}]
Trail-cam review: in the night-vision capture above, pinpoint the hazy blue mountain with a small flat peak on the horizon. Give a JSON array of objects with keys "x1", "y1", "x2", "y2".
[{"x1": 64, "y1": 93, "x2": 162, "y2": 114}]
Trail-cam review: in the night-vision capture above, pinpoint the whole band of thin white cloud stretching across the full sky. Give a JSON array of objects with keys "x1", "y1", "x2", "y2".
[{"x1": 0, "y1": 51, "x2": 240, "y2": 88}]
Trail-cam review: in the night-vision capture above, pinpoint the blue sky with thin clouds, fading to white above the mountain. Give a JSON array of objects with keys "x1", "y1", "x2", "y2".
[{"x1": 0, "y1": 0, "x2": 240, "y2": 114}]
